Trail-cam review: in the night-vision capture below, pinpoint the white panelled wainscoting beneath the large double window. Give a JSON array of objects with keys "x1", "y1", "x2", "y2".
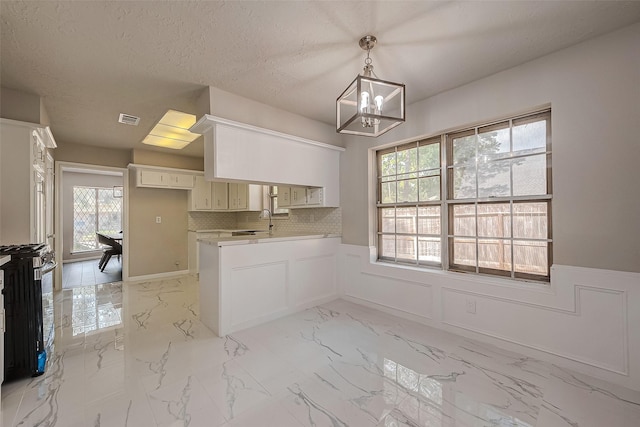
[{"x1": 338, "y1": 245, "x2": 640, "y2": 390}]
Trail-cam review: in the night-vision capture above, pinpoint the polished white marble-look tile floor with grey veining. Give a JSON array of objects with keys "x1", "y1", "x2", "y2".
[{"x1": 2, "y1": 277, "x2": 640, "y2": 427}]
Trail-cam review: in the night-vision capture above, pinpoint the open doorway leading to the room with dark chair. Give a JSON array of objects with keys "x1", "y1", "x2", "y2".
[{"x1": 55, "y1": 162, "x2": 128, "y2": 289}]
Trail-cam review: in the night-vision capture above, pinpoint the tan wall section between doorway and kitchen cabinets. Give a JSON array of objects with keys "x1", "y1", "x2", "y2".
[{"x1": 128, "y1": 173, "x2": 188, "y2": 278}]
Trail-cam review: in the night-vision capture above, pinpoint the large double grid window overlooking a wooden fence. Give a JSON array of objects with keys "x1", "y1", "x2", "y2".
[{"x1": 377, "y1": 111, "x2": 552, "y2": 281}]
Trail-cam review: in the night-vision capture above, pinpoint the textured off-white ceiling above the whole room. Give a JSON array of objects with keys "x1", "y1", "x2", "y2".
[{"x1": 0, "y1": 0, "x2": 640, "y2": 156}]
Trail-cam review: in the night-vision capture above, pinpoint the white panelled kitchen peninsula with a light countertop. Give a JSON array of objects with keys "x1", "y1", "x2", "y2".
[{"x1": 198, "y1": 234, "x2": 340, "y2": 336}]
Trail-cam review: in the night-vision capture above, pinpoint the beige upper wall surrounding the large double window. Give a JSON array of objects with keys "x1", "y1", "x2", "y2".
[{"x1": 341, "y1": 24, "x2": 640, "y2": 272}]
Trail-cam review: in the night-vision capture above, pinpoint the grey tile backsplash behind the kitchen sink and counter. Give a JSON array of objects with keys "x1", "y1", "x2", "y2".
[{"x1": 189, "y1": 208, "x2": 342, "y2": 234}]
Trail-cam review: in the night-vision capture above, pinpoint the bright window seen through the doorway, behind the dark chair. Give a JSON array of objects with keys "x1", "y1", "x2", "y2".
[{"x1": 72, "y1": 187, "x2": 122, "y2": 252}]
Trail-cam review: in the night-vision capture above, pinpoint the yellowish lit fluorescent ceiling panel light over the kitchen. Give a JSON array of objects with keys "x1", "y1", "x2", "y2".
[{"x1": 142, "y1": 110, "x2": 200, "y2": 150}]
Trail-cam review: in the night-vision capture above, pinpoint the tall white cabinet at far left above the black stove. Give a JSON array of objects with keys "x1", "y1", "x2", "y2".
[{"x1": 0, "y1": 119, "x2": 56, "y2": 244}]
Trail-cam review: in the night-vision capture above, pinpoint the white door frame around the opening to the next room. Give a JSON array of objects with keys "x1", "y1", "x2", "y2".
[{"x1": 53, "y1": 161, "x2": 129, "y2": 290}]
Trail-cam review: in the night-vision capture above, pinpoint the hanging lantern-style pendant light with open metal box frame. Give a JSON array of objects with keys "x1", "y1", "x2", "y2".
[{"x1": 336, "y1": 36, "x2": 404, "y2": 137}]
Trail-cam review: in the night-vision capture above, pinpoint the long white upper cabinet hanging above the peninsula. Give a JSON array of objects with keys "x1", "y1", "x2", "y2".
[{"x1": 190, "y1": 114, "x2": 344, "y2": 206}]
